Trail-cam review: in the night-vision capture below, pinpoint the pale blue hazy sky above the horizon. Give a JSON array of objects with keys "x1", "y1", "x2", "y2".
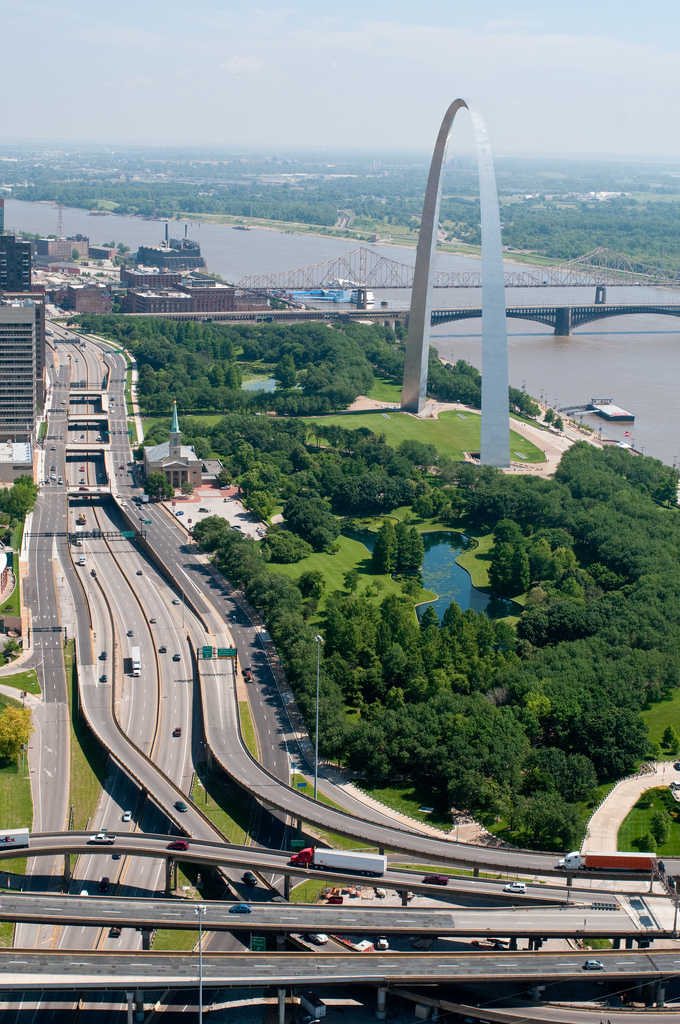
[{"x1": 5, "y1": 0, "x2": 680, "y2": 157}]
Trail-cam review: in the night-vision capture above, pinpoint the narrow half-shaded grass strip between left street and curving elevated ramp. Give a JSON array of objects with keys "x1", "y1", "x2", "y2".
[{"x1": 63, "y1": 640, "x2": 108, "y2": 829}]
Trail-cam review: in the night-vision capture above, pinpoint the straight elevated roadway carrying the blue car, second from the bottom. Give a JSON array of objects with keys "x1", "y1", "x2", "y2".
[{"x1": 0, "y1": 893, "x2": 673, "y2": 940}]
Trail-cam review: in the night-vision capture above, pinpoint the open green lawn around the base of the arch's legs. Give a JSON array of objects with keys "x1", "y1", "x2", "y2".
[{"x1": 305, "y1": 410, "x2": 546, "y2": 463}]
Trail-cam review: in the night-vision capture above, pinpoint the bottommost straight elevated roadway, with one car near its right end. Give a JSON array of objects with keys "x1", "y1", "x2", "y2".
[{"x1": 0, "y1": 949, "x2": 680, "y2": 991}]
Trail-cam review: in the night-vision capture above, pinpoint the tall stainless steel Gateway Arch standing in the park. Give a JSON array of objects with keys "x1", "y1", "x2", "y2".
[{"x1": 401, "y1": 99, "x2": 510, "y2": 467}]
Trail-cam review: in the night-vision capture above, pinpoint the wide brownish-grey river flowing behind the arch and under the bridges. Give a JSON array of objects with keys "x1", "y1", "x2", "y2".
[{"x1": 5, "y1": 199, "x2": 680, "y2": 465}]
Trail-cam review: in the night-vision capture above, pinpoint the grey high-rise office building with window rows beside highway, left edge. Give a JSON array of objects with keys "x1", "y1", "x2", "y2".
[{"x1": 0, "y1": 299, "x2": 37, "y2": 441}]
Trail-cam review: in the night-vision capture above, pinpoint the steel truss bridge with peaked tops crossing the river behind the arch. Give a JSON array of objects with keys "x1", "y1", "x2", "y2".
[{"x1": 239, "y1": 247, "x2": 680, "y2": 292}]
